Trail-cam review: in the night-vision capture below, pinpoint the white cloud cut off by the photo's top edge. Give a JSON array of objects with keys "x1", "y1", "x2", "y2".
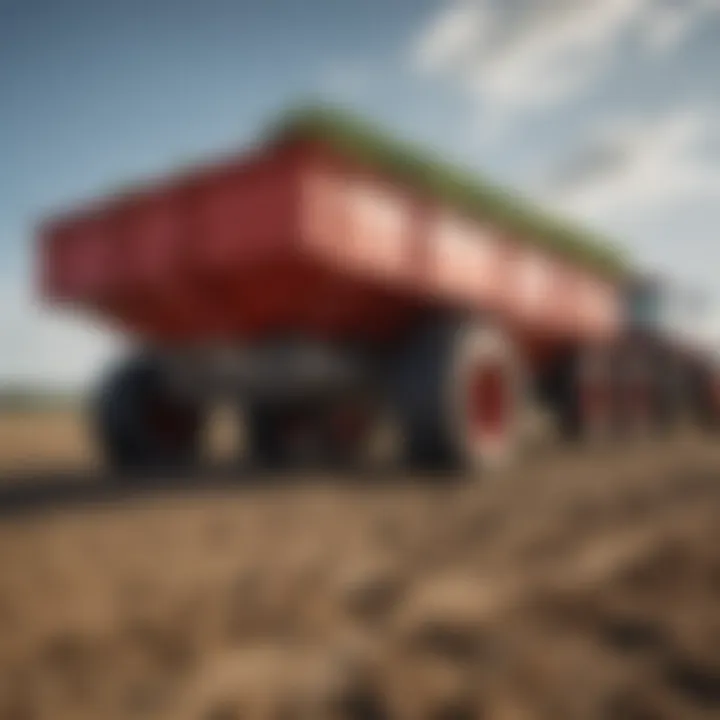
[{"x1": 411, "y1": 0, "x2": 720, "y2": 119}]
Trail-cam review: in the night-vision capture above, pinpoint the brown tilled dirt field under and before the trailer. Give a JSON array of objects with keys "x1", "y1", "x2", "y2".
[{"x1": 0, "y1": 410, "x2": 720, "y2": 720}]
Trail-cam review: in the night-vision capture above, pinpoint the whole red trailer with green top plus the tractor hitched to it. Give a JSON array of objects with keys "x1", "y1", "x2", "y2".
[{"x1": 39, "y1": 109, "x2": 720, "y2": 469}]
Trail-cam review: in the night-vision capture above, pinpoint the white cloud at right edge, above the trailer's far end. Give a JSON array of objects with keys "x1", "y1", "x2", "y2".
[{"x1": 544, "y1": 109, "x2": 720, "y2": 219}]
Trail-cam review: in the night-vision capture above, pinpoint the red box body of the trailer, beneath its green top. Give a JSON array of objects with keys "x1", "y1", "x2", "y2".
[{"x1": 41, "y1": 140, "x2": 622, "y2": 366}]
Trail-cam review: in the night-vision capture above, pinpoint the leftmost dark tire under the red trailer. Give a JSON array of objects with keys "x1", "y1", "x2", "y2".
[{"x1": 95, "y1": 357, "x2": 201, "y2": 473}]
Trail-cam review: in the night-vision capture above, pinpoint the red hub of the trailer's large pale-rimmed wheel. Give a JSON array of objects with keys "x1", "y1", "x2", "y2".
[{"x1": 468, "y1": 363, "x2": 509, "y2": 439}]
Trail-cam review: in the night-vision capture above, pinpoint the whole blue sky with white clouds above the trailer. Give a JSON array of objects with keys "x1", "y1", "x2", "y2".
[{"x1": 0, "y1": 0, "x2": 720, "y2": 384}]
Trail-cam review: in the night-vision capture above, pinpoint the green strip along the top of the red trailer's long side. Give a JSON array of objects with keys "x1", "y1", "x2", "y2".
[{"x1": 268, "y1": 105, "x2": 631, "y2": 280}]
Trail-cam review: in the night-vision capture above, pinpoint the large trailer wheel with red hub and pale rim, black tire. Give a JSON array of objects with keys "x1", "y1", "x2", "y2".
[{"x1": 390, "y1": 320, "x2": 525, "y2": 470}]
